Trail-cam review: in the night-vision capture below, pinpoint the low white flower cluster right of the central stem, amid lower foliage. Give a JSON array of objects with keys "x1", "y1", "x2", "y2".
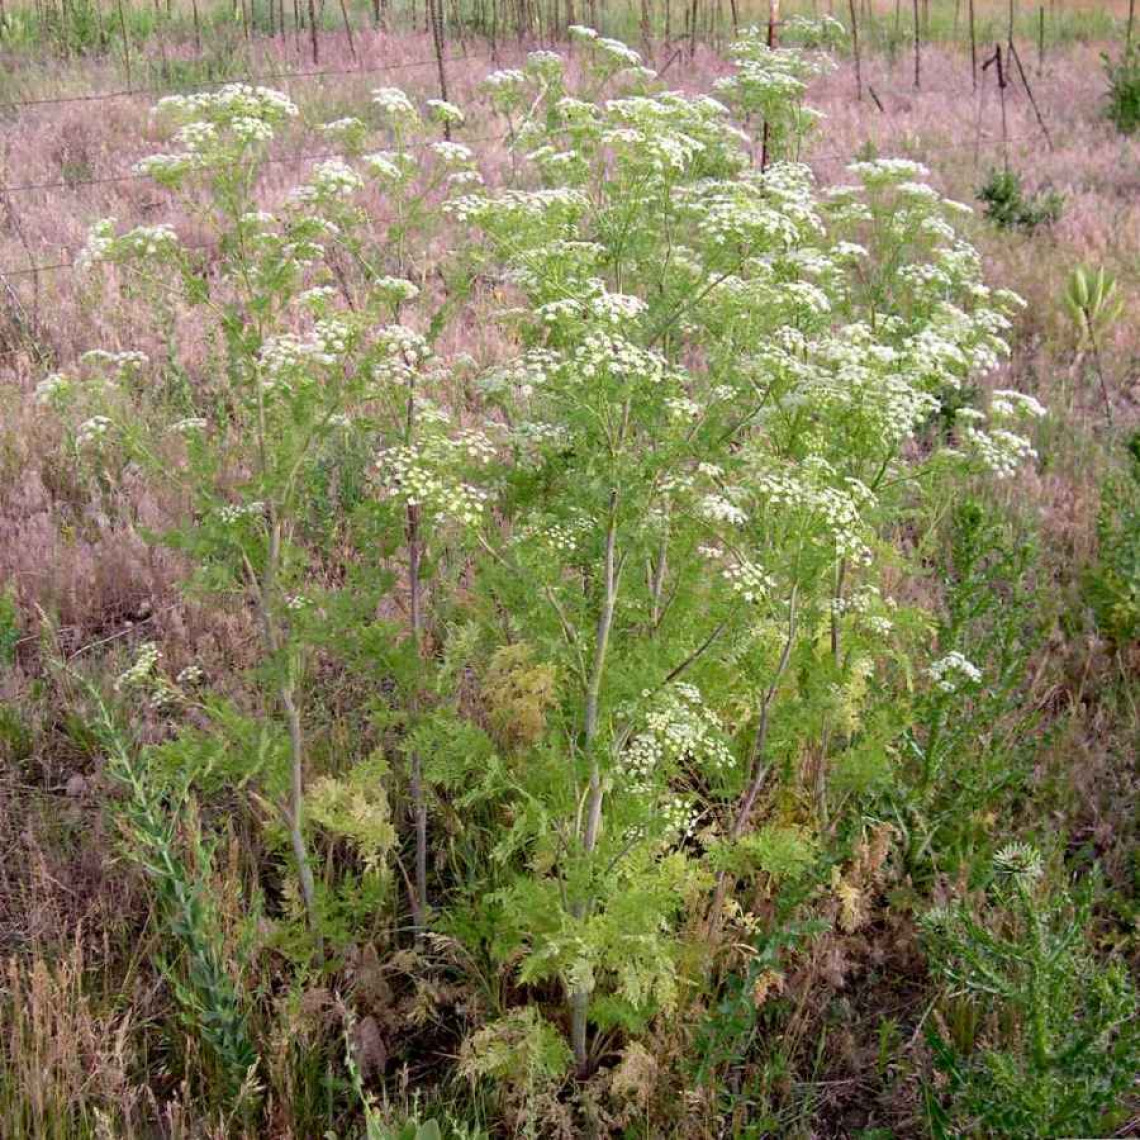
[{"x1": 619, "y1": 682, "x2": 736, "y2": 795}]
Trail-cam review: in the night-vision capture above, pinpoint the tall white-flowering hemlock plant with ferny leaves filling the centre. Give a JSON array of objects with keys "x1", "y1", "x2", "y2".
[{"x1": 41, "y1": 20, "x2": 1043, "y2": 1112}]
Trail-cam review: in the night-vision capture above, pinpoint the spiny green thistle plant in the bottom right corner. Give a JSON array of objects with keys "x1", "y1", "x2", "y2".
[{"x1": 923, "y1": 844, "x2": 1140, "y2": 1138}]
